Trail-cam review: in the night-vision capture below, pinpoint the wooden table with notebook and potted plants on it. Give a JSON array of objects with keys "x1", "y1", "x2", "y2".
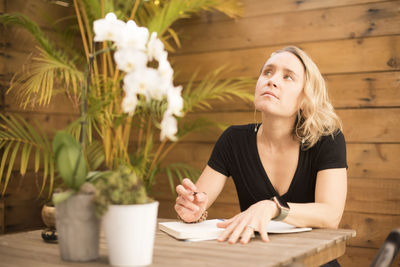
[{"x1": 0, "y1": 222, "x2": 356, "y2": 267}]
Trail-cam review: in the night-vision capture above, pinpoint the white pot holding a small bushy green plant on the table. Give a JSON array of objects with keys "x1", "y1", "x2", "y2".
[{"x1": 95, "y1": 165, "x2": 158, "y2": 266}]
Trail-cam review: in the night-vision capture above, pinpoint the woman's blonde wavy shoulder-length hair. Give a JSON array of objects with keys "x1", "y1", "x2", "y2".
[{"x1": 271, "y1": 46, "x2": 342, "y2": 149}]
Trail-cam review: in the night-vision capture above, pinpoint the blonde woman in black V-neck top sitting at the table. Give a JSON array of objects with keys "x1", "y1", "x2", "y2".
[{"x1": 175, "y1": 47, "x2": 347, "y2": 266}]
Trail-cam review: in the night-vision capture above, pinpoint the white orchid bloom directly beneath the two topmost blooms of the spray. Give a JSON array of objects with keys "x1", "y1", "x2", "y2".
[{"x1": 114, "y1": 48, "x2": 147, "y2": 73}]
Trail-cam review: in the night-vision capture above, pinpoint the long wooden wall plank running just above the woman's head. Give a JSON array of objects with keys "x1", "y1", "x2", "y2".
[{"x1": 178, "y1": 1, "x2": 400, "y2": 53}]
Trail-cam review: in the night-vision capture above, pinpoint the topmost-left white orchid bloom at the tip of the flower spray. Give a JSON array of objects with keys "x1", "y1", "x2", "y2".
[{"x1": 93, "y1": 13, "x2": 125, "y2": 42}]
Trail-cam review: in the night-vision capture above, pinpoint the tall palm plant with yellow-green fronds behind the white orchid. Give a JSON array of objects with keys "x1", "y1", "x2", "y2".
[{"x1": 0, "y1": 0, "x2": 255, "y2": 203}]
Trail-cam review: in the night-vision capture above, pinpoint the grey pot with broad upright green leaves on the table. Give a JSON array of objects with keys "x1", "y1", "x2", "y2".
[{"x1": 53, "y1": 131, "x2": 99, "y2": 261}]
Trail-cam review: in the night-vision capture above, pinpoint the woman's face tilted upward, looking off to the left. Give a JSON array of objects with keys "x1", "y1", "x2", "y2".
[{"x1": 254, "y1": 52, "x2": 305, "y2": 117}]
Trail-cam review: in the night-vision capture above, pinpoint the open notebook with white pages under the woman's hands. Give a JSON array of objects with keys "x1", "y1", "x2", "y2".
[{"x1": 158, "y1": 219, "x2": 311, "y2": 241}]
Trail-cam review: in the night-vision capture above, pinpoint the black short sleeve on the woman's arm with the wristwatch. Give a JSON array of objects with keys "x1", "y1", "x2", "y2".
[{"x1": 316, "y1": 131, "x2": 347, "y2": 171}]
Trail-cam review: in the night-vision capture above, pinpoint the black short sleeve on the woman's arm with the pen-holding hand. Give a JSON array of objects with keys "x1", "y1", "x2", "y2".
[{"x1": 208, "y1": 126, "x2": 232, "y2": 177}]
